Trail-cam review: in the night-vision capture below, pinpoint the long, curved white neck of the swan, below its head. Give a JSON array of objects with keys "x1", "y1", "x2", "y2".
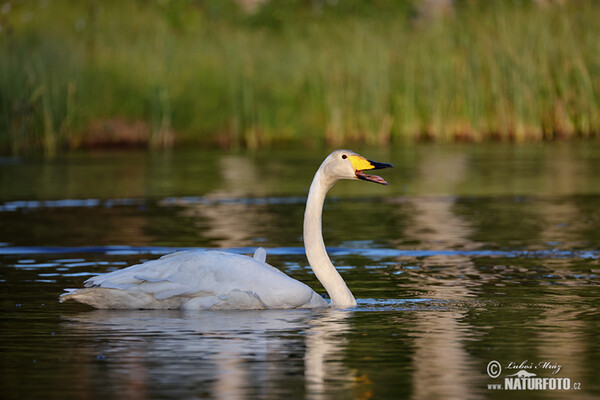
[{"x1": 304, "y1": 168, "x2": 356, "y2": 307}]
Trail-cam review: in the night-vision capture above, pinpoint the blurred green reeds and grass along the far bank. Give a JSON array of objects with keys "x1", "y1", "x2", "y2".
[{"x1": 0, "y1": 0, "x2": 600, "y2": 154}]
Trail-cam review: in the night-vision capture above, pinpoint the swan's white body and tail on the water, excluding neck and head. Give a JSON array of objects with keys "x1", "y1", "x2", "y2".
[{"x1": 61, "y1": 250, "x2": 327, "y2": 309}]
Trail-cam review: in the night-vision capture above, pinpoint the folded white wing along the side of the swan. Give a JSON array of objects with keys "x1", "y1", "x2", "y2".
[{"x1": 85, "y1": 250, "x2": 322, "y2": 308}]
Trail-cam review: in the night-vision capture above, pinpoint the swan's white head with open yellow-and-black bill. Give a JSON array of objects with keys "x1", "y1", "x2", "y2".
[{"x1": 321, "y1": 150, "x2": 392, "y2": 185}]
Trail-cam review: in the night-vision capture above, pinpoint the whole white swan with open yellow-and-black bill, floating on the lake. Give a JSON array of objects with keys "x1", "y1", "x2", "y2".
[{"x1": 59, "y1": 150, "x2": 392, "y2": 310}]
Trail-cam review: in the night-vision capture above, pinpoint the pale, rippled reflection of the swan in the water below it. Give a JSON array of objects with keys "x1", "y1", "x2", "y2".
[{"x1": 63, "y1": 309, "x2": 358, "y2": 399}]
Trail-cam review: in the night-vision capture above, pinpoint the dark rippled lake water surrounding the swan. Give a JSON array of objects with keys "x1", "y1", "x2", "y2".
[{"x1": 0, "y1": 143, "x2": 600, "y2": 399}]
